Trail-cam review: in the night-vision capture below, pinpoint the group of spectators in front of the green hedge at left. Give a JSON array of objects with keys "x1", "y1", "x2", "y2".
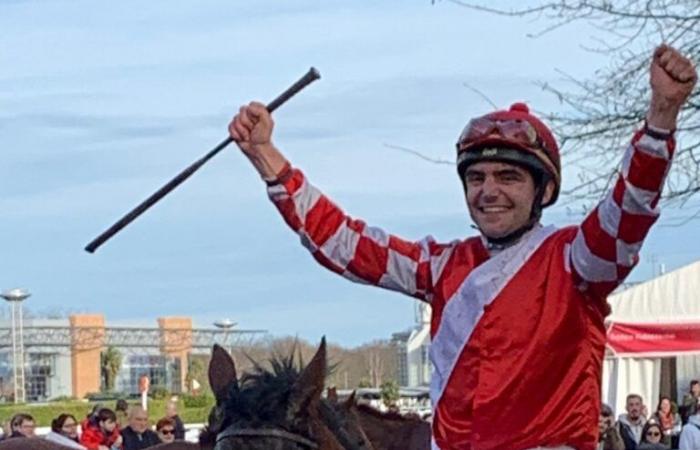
[{"x1": 0, "y1": 400, "x2": 185, "y2": 450}]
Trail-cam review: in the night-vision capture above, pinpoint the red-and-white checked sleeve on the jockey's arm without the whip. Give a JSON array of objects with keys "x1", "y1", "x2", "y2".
[{"x1": 570, "y1": 128, "x2": 675, "y2": 297}]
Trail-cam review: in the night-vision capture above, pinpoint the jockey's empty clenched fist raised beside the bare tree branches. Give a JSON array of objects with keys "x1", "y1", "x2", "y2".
[{"x1": 647, "y1": 44, "x2": 698, "y2": 130}]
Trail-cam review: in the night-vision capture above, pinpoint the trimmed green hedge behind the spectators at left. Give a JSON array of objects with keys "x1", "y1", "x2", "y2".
[{"x1": 0, "y1": 397, "x2": 214, "y2": 427}]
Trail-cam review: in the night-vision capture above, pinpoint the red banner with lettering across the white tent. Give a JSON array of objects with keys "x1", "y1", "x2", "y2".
[{"x1": 608, "y1": 323, "x2": 700, "y2": 357}]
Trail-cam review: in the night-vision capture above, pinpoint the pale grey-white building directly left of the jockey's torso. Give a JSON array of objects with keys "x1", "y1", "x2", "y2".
[{"x1": 391, "y1": 302, "x2": 432, "y2": 388}]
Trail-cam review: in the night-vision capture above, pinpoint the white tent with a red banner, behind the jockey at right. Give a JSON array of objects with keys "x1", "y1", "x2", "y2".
[{"x1": 603, "y1": 261, "x2": 700, "y2": 414}]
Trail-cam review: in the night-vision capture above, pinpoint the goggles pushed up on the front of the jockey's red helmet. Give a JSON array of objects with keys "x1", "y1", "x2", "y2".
[{"x1": 457, "y1": 117, "x2": 548, "y2": 153}]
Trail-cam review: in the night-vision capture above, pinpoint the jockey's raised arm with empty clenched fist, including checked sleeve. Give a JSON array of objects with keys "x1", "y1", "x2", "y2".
[{"x1": 570, "y1": 45, "x2": 697, "y2": 296}]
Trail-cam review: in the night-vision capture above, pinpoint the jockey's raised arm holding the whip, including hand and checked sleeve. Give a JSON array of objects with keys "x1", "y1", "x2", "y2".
[{"x1": 229, "y1": 103, "x2": 438, "y2": 301}]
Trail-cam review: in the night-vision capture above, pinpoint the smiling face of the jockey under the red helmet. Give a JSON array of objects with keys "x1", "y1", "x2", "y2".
[{"x1": 464, "y1": 162, "x2": 535, "y2": 238}]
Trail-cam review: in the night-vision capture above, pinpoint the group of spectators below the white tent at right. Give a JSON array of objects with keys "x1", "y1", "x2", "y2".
[{"x1": 598, "y1": 380, "x2": 700, "y2": 450}]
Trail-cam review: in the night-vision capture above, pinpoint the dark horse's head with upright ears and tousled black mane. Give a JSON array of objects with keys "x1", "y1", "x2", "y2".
[{"x1": 200, "y1": 338, "x2": 374, "y2": 450}]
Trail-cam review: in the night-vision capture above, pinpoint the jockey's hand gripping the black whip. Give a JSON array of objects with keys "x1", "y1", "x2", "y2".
[{"x1": 228, "y1": 102, "x2": 274, "y2": 156}]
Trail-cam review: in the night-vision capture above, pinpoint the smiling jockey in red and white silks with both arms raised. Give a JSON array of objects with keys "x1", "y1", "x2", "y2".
[{"x1": 229, "y1": 45, "x2": 697, "y2": 450}]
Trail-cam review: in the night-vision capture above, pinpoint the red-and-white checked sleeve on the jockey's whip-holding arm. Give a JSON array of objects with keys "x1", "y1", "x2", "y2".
[{"x1": 268, "y1": 169, "x2": 445, "y2": 302}]
